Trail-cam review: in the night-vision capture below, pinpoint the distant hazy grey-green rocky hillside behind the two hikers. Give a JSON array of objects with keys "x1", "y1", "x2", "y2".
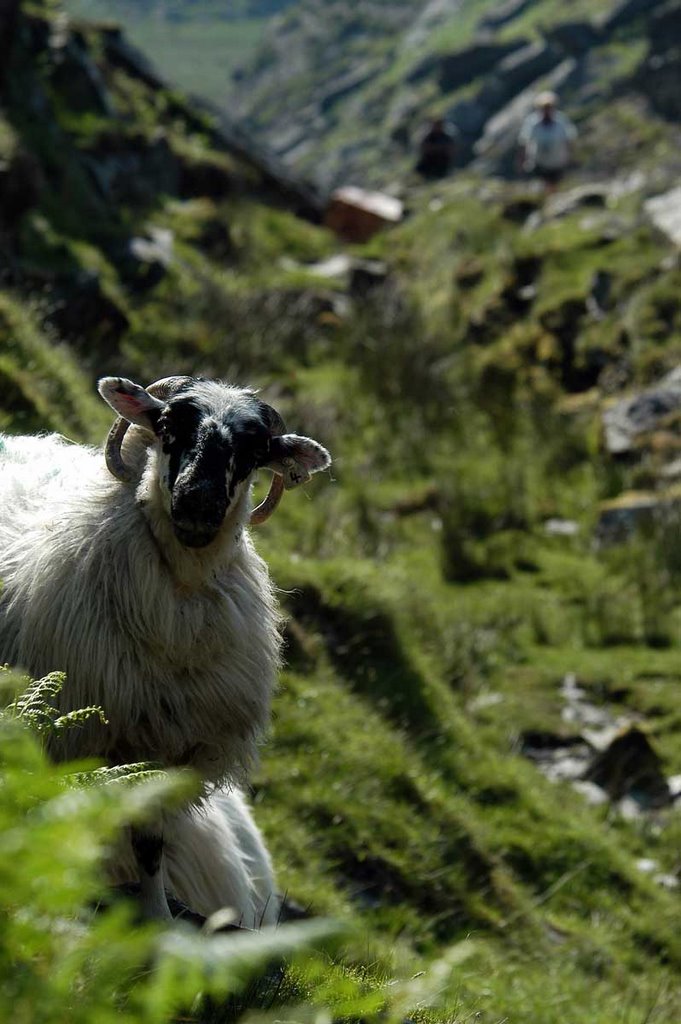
[{"x1": 229, "y1": 0, "x2": 679, "y2": 186}]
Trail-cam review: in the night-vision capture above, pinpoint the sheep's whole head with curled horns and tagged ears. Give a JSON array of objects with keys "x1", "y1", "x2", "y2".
[{"x1": 97, "y1": 377, "x2": 331, "y2": 548}]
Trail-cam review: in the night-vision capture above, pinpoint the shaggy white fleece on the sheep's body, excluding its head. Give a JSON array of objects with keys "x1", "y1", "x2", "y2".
[{"x1": 0, "y1": 428, "x2": 281, "y2": 922}]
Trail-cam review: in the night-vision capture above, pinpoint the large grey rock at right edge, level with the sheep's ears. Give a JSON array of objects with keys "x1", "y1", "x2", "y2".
[{"x1": 603, "y1": 367, "x2": 681, "y2": 455}]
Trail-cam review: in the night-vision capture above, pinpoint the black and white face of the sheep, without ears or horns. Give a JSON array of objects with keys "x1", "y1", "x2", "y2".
[{"x1": 156, "y1": 397, "x2": 270, "y2": 548}]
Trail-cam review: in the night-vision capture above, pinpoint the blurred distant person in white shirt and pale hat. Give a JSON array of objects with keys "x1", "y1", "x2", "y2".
[{"x1": 518, "y1": 92, "x2": 577, "y2": 190}]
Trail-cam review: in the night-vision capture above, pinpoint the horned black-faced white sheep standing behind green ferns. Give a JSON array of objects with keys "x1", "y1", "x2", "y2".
[{"x1": 0, "y1": 377, "x2": 331, "y2": 927}]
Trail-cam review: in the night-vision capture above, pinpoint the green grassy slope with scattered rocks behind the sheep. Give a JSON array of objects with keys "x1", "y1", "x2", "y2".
[{"x1": 0, "y1": 5, "x2": 681, "y2": 1024}]
